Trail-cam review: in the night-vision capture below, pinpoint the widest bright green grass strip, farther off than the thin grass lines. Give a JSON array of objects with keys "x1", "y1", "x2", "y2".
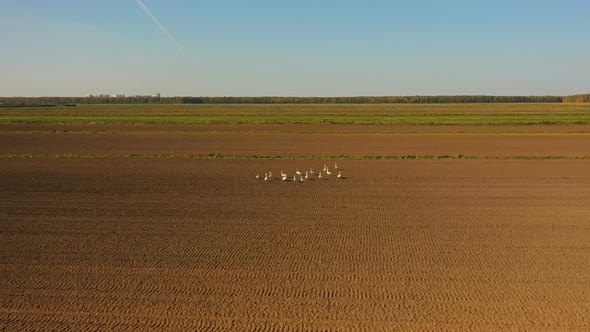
[{"x1": 0, "y1": 114, "x2": 590, "y2": 125}]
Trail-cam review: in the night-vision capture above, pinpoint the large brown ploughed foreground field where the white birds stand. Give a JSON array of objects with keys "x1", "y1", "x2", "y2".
[{"x1": 0, "y1": 158, "x2": 590, "y2": 331}]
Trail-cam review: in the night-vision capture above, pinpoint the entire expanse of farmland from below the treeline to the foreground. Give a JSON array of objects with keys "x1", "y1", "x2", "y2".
[{"x1": 0, "y1": 104, "x2": 590, "y2": 331}]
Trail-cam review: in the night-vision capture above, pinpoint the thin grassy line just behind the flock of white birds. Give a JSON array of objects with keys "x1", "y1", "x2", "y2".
[{"x1": 0, "y1": 153, "x2": 590, "y2": 160}]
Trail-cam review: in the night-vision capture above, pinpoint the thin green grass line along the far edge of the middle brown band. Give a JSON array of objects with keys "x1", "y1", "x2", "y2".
[{"x1": 0, "y1": 127, "x2": 590, "y2": 136}]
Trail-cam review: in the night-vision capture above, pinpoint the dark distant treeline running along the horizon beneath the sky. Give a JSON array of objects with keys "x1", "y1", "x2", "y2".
[{"x1": 0, "y1": 95, "x2": 590, "y2": 106}]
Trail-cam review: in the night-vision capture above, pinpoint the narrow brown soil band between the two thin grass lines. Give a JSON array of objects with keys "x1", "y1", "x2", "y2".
[{"x1": 0, "y1": 133, "x2": 590, "y2": 156}]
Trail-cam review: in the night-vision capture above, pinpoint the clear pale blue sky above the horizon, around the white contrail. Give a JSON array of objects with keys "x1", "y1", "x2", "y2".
[{"x1": 0, "y1": 0, "x2": 590, "y2": 96}]
